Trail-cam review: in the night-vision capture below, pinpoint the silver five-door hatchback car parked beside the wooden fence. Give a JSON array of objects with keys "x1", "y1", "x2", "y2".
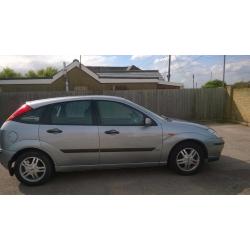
[{"x1": 0, "y1": 96, "x2": 224, "y2": 185}]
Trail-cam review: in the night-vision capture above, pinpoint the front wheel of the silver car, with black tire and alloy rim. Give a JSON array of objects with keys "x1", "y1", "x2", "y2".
[{"x1": 168, "y1": 142, "x2": 205, "y2": 175}]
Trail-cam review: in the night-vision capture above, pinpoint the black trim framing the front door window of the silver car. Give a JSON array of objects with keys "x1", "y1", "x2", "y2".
[{"x1": 93, "y1": 99, "x2": 158, "y2": 127}]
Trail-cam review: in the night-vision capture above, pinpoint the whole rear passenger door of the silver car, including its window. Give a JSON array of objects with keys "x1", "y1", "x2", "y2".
[{"x1": 39, "y1": 100, "x2": 99, "y2": 165}]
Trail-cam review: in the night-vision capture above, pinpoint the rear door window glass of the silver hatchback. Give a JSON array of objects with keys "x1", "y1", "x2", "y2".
[{"x1": 50, "y1": 101, "x2": 93, "y2": 125}]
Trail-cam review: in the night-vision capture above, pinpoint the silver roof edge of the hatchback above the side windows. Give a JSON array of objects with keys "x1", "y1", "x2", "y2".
[{"x1": 26, "y1": 95, "x2": 129, "y2": 108}]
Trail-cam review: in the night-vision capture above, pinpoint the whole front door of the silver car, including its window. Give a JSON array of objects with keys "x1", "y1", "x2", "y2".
[{"x1": 96, "y1": 101, "x2": 162, "y2": 164}]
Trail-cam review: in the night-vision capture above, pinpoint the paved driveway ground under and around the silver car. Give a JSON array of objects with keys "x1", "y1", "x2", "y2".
[{"x1": 0, "y1": 124, "x2": 250, "y2": 194}]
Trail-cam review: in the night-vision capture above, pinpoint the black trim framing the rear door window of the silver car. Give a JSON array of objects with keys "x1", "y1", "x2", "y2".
[{"x1": 39, "y1": 100, "x2": 97, "y2": 126}]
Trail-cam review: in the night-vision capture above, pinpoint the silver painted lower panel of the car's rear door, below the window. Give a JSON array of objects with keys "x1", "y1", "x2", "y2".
[{"x1": 39, "y1": 125, "x2": 99, "y2": 166}]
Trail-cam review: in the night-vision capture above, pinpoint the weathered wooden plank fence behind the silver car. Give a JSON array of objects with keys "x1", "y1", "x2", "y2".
[{"x1": 0, "y1": 88, "x2": 227, "y2": 123}]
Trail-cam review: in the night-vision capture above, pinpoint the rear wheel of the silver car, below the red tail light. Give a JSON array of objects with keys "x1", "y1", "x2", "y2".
[{"x1": 15, "y1": 151, "x2": 54, "y2": 186}]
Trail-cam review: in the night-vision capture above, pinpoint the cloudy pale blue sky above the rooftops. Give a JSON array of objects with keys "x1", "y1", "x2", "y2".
[{"x1": 0, "y1": 55, "x2": 250, "y2": 88}]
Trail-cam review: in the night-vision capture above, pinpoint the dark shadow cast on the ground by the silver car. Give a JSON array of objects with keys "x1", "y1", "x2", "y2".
[{"x1": 19, "y1": 156, "x2": 250, "y2": 195}]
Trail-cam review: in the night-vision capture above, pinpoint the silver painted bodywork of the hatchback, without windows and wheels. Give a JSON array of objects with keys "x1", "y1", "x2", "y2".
[{"x1": 0, "y1": 96, "x2": 223, "y2": 171}]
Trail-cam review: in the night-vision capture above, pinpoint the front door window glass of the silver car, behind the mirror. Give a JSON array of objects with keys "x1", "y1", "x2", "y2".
[{"x1": 97, "y1": 101, "x2": 144, "y2": 126}]
